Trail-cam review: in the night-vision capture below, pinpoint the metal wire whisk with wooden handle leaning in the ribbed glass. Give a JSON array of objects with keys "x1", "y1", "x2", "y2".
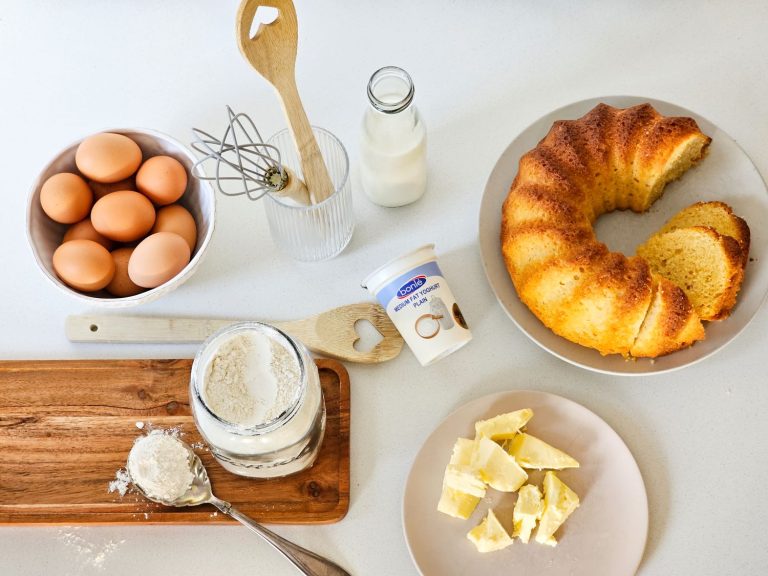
[{"x1": 192, "y1": 106, "x2": 310, "y2": 204}]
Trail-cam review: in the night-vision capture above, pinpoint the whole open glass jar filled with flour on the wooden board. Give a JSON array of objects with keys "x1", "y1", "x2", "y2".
[{"x1": 189, "y1": 322, "x2": 325, "y2": 478}]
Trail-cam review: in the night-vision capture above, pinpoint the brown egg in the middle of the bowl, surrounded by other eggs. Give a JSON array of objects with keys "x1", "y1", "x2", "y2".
[{"x1": 91, "y1": 190, "x2": 155, "y2": 242}]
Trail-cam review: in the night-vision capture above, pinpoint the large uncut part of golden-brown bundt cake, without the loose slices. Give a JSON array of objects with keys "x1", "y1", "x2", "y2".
[{"x1": 501, "y1": 104, "x2": 711, "y2": 357}]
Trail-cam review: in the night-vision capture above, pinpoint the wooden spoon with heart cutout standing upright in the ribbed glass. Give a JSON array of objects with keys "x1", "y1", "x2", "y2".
[{"x1": 236, "y1": 0, "x2": 334, "y2": 204}]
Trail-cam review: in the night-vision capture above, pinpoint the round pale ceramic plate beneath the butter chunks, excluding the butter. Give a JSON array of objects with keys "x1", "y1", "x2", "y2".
[{"x1": 403, "y1": 391, "x2": 648, "y2": 576}]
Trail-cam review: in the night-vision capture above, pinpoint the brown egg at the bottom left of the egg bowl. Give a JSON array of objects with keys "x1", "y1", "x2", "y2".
[{"x1": 53, "y1": 240, "x2": 115, "y2": 292}]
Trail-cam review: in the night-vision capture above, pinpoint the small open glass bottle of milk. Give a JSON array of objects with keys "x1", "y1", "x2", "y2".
[{"x1": 360, "y1": 66, "x2": 427, "y2": 206}]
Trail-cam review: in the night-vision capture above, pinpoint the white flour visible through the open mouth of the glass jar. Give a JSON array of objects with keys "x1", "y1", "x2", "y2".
[{"x1": 203, "y1": 330, "x2": 301, "y2": 427}]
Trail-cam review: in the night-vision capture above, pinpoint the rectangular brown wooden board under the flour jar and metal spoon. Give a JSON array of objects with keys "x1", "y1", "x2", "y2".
[{"x1": 0, "y1": 360, "x2": 350, "y2": 525}]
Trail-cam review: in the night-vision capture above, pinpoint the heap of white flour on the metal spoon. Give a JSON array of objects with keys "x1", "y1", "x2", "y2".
[{"x1": 127, "y1": 430, "x2": 194, "y2": 501}]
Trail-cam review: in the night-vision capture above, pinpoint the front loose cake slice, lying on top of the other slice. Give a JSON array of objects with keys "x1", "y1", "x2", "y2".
[{"x1": 637, "y1": 226, "x2": 744, "y2": 320}]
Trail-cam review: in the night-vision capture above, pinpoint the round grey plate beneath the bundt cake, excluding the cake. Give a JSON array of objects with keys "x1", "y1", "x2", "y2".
[{"x1": 479, "y1": 96, "x2": 768, "y2": 375}]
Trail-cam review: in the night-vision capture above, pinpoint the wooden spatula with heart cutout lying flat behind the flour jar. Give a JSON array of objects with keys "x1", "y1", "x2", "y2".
[{"x1": 65, "y1": 302, "x2": 403, "y2": 364}]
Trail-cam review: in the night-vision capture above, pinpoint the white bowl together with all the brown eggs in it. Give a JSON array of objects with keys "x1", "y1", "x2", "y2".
[{"x1": 27, "y1": 129, "x2": 216, "y2": 308}]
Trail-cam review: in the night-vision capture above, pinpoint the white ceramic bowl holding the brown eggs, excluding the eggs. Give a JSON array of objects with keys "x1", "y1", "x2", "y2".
[{"x1": 27, "y1": 128, "x2": 216, "y2": 308}]
